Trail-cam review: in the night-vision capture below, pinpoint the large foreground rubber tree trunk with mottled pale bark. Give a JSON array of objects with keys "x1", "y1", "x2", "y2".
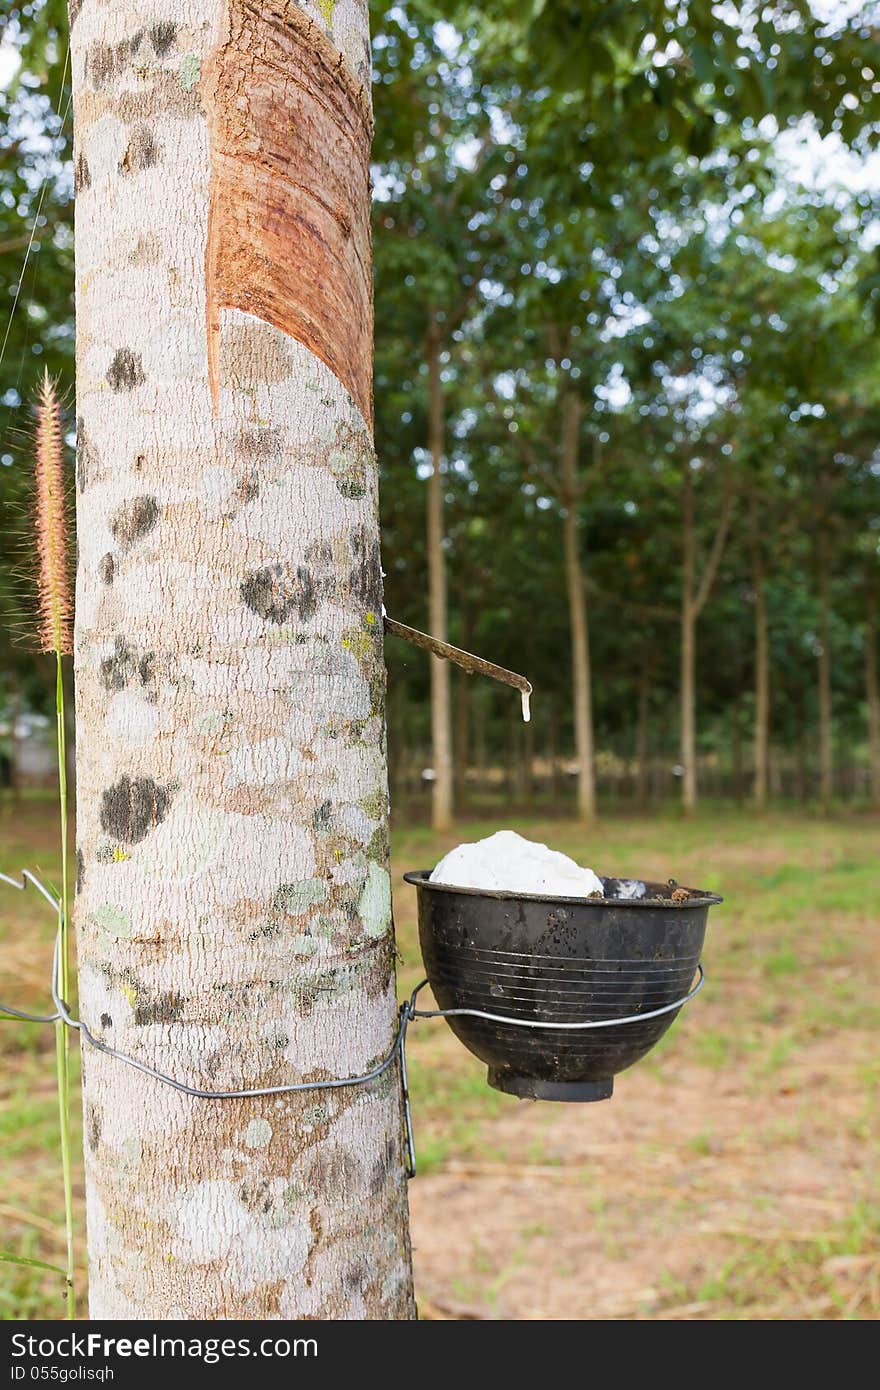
[{"x1": 72, "y1": 0, "x2": 413, "y2": 1319}]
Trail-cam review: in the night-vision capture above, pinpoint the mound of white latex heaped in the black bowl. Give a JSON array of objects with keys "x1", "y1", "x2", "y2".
[{"x1": 431, "y1": 830, "x2": 602, "y2": 898}]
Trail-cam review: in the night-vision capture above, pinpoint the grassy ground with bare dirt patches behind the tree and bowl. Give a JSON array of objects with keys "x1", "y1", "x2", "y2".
[{"x1": 0, "y1": 799, "x2": 880, "y2": 1319}]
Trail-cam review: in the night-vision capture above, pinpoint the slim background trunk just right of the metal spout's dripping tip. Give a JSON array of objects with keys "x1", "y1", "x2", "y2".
[{"x1": 560, "y1": 392, "x2": 596, "y2": 821}]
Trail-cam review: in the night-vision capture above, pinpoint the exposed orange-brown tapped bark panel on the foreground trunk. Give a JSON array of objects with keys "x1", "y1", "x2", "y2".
[{"x1": 204, "y1": 0, "x2": 373, "y2": 425}]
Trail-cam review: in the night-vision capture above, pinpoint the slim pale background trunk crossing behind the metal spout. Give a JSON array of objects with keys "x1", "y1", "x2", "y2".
[{"x1": 427, "y1": 321, "x2": 453, "y2": 831}]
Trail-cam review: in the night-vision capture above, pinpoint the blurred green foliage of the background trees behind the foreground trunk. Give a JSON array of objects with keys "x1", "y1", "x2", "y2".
[{"x1": 0, "y1": 0, "x2": 880, "y2": 790}]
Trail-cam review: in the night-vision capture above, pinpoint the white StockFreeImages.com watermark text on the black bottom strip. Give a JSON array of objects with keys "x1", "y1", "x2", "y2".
[{"x1": 10, "y1": 1332, "x2": 318, "y2": 1362}]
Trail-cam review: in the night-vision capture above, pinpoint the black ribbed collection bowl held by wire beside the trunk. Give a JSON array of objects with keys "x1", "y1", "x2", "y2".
[{"x1": 403, "y1": 869, "x2": 722, "y2": 1101}]
